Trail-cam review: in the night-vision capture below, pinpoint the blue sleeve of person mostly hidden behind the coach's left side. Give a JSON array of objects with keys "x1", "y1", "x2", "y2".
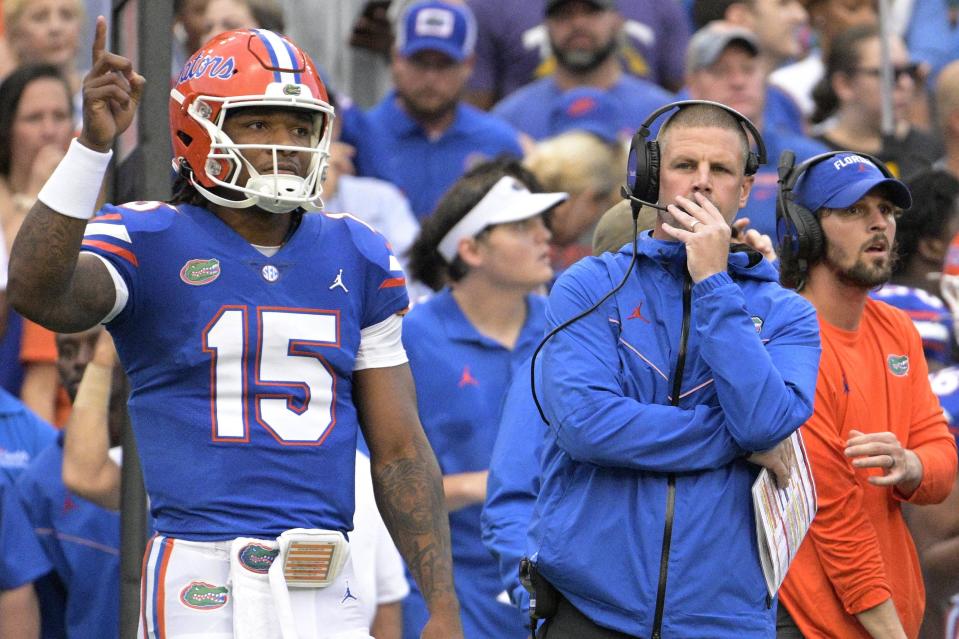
[{"x1": 480, "y1": 361, "x2": 546, "y2": 614}]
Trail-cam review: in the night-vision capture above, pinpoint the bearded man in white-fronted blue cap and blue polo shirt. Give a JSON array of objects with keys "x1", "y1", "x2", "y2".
[{"x1": 367, "y1": 1, "x2": 522, "y2": 219}]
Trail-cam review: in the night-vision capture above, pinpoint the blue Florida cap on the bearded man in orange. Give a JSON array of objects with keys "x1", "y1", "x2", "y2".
[{"x1": 793, "y1": 152, "x2": 912, "y2": 213}]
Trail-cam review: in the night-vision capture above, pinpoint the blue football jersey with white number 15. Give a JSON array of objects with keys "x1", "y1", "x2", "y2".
[{"x1": 83, "y1": 203, "x2": 408, "y2": 541}]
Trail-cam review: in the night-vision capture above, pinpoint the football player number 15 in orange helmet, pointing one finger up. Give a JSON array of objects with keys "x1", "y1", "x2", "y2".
[{"x1": 8, "y1": 18, "x2": 462, "y2": 639}]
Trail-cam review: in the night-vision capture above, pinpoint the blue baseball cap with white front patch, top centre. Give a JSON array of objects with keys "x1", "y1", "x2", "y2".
[{"x1": 396, "y1": 1, "x2": 476, "y2": 62}]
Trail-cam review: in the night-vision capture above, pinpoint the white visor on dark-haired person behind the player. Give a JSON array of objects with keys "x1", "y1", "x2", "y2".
[{"x1": 436, "y1": 175, "x2": 569, "y2": 262}]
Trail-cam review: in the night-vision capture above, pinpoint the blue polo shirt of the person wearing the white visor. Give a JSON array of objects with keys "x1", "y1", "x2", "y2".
[{"x1": 403, "y1": 289, "x2": 546, "y2": 639}]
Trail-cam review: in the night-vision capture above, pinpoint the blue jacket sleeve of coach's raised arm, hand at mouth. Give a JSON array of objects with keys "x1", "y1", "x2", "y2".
[{"x1": 693, "y1": 273, "x2": 820, "y2": 451}]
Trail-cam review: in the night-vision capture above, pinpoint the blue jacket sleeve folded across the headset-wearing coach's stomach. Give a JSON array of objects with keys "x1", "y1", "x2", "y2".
[{"x1": 537, "y1": 262, "x2": 746, "y2": 472}]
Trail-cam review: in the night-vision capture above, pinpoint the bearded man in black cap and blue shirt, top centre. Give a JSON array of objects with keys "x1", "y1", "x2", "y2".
[{"x1": 493, "y1": 0, "x2": 672, "y2": 140}]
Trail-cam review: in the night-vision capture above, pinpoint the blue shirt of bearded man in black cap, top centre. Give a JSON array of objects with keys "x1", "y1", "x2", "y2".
[{"x1": 493, "y1": 74, "x2": 674, "y2": 140}]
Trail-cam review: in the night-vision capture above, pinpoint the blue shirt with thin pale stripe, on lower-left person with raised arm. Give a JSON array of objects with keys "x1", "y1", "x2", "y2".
[{"x1": 17, "y1": 436, "x2": 120, "y2": 639}]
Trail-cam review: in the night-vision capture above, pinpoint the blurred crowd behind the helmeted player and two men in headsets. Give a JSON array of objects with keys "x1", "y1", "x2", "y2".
[{"x1": 0, "y1": 0, "x2": 959, "y2": 639}]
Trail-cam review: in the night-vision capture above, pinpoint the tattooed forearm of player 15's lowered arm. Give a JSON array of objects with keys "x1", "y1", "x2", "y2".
[{"x1": 373, "y1": 435, "x2": 453, "y2": 602}]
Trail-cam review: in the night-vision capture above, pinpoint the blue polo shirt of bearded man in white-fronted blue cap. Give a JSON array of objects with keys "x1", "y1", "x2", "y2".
[{"x1": 367, "y1": 91, "x2": 523, "y2": 219}]
